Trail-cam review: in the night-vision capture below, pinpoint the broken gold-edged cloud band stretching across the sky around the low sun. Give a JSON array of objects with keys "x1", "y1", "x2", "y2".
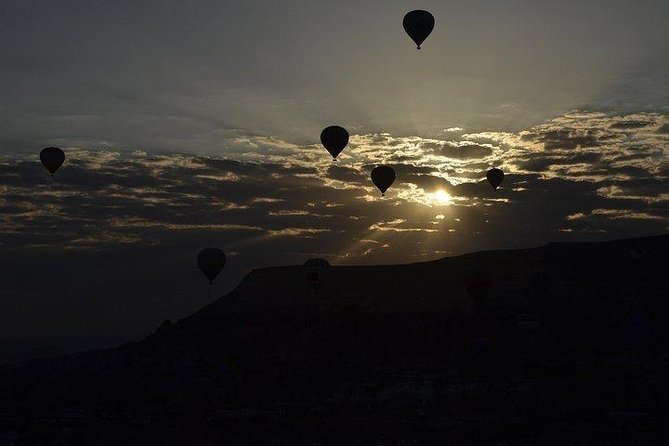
[{"x1": 0, "y1": 112, "x2": 668, "y2": 258}]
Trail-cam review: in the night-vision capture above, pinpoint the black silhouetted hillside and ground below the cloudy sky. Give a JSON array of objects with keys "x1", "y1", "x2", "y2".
[{"x1": 0, "y1": 236, "x2": 669, "y2": 445}]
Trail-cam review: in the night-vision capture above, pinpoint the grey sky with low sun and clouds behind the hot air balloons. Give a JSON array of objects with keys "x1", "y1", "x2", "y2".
[{"x1": 0, "y1": 0, "x2": 669, "y2": 349}]
